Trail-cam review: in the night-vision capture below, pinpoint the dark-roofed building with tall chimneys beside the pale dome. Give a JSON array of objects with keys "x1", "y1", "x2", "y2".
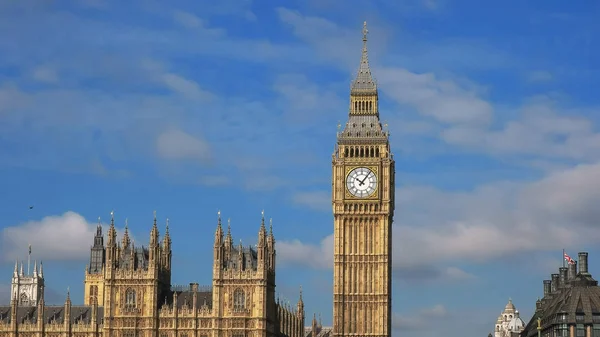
[{"x1": 521, "y1": 252, "x2": 600, "y2": 337}]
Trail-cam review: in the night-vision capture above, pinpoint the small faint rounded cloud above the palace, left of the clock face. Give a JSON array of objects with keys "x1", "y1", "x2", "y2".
[{"x1": 156, "y1": 129, "x2": 211, "y2": 163}]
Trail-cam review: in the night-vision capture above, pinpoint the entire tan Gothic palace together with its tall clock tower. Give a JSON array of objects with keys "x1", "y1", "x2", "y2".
[{"x1": 0, "y1": 22, "x2": 395, "y2": 337}]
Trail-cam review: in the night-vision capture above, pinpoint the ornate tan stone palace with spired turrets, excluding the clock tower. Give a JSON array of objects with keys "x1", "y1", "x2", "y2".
[{"x1": 0, "y1": 213, "x2": 304, "y2": 337}]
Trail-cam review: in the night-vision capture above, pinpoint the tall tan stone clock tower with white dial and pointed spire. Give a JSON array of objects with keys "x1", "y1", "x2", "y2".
[{"x1": 332, "y1": 22, "x2": 394, "y2": 337}]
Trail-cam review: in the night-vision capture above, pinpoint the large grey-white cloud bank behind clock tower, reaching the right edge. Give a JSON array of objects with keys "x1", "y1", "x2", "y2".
[{"x1": 278, "y1": 160, "x2": 600, "y2": 281}]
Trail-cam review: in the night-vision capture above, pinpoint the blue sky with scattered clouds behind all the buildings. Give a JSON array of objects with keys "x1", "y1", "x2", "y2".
[{"x1": 0, "y1": 0, "x2": 600, "y2": 336}]
